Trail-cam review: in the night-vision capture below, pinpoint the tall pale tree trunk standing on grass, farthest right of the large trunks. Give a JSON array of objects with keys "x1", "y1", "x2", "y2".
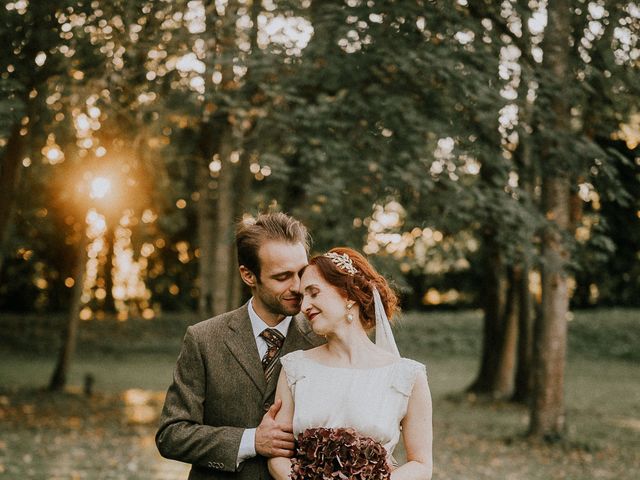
[{"x1": 529, "y1": 0, "x2": 571, "y2": 439}]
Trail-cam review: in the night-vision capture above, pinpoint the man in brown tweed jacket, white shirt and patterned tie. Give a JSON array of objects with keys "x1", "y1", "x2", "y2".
[{"x1": 156, "y1": 213, "x2": 322, "y2": 480}]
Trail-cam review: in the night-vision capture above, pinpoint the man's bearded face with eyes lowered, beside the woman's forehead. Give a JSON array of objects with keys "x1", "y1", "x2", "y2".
[{"x1": 253, "y1": 241, "x2": 307, "y2": 321}]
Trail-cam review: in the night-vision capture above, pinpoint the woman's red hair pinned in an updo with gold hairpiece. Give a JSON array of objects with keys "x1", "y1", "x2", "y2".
[{"x1": 309, "y1": 247, "x2": 398, "y2": 330}]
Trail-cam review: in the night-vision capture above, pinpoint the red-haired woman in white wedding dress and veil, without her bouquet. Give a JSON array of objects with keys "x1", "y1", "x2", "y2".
[{"x1": 269, "y1": 248, "x2": 432, "y2": 480}]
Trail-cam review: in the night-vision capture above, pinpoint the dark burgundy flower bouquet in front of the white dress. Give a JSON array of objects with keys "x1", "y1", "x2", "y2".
[{"x1": 290, "y1": 428, "x2": 391, "y2": 480}]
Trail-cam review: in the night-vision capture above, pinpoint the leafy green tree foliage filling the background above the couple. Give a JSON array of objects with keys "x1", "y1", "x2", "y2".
[{"x1": 0, "y1": 0, "x2": 640, "y2": 308}]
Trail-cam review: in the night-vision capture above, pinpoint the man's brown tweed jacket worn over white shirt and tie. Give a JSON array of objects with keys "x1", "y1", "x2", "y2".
[{"x1": 156, "y1": 304, "x2": 324, "y2": 480}]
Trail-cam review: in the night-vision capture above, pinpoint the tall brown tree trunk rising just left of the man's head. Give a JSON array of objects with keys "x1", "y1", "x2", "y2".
[{"x1": 198, "y1": 1, "x2": 244, "y2": 316}]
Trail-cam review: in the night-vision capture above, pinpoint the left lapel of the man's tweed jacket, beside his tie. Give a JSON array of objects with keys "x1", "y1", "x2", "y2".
[{"x1": 224, "y1": 305, "x2": 266, "y2": 394}]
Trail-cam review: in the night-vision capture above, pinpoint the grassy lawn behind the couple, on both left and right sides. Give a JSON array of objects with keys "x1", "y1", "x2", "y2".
[{"x1": 0, "y1": 310, "x2": 640, "y2": 480}]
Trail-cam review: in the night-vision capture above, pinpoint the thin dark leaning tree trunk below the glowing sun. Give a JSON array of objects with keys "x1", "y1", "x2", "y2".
[{"x1": 49, "y1": 232, "x2": 89, "y2": 391}]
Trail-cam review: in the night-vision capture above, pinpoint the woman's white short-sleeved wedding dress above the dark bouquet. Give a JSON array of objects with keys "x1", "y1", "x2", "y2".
[{"x1": 280, "y1": 350, "x2": 426, "y2": 456}]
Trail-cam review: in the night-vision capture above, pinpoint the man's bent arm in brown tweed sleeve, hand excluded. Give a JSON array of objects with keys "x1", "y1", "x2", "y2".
[{"x1": 156, "y1": 327, "x2": 245, "y2": 472}]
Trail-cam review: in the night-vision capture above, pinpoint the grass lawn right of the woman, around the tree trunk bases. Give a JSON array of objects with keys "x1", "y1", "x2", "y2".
[{"x1": 430, "y1": 359, "x2": 640, "y2": 480}]
